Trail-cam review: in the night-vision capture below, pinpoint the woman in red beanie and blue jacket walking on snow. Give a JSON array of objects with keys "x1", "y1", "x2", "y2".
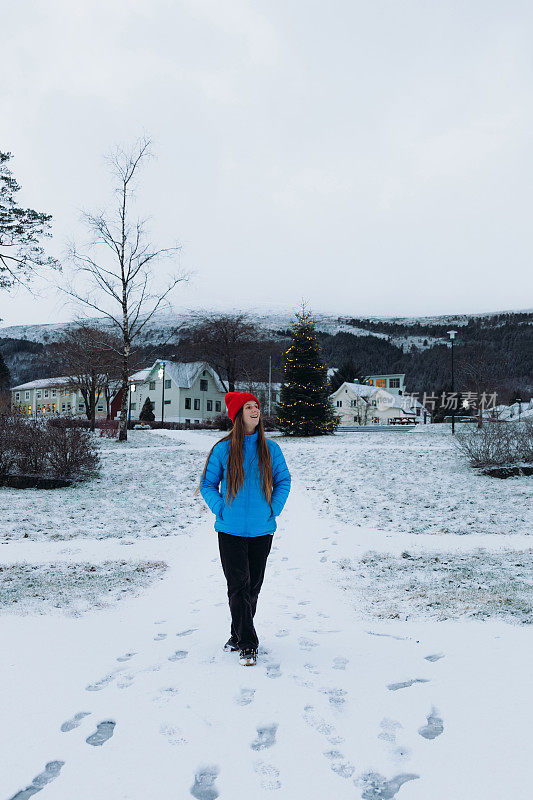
[{"x1": 196, "y1": 392, "x2": 291, "y2": 667}]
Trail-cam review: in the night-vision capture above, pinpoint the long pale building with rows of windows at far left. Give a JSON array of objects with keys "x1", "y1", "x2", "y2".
[{"x1": 11, "y1": 376, "x2": 112, "y2": 419}]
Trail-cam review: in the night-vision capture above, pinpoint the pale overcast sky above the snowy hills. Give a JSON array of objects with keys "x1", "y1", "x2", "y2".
[{"x1": 0, "y1": 0, "x2": 533, "y2": 325}]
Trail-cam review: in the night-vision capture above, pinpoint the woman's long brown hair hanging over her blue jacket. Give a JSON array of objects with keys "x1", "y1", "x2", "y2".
[{"x1": 194, "y1": 408, "x2": 272, "y2": 503}]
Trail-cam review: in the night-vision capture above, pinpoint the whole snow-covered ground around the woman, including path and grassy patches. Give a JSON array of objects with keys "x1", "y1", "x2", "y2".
[{"x1": 0, "y1": 426, "x2": 533, "y2": 800}]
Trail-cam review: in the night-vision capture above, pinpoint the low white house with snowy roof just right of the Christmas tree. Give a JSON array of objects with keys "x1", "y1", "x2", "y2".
[{"x1": 329, "y1": 382, "x2": 431, "y2": 428}]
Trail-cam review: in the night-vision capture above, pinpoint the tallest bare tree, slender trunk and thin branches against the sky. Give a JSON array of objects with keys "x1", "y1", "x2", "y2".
[{"x1": 64, "y1": 137, "x2": 189, "y2": 441}]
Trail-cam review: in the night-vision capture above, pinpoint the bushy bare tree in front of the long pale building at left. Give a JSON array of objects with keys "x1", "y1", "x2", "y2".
[{"x1": 51, "y1": 325, "x2": 121, "y2": 431}]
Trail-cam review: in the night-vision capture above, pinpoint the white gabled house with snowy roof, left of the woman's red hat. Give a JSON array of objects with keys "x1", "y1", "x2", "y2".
[{"x1": 128, "y1": 359, "x2": 226, "y2": 424}]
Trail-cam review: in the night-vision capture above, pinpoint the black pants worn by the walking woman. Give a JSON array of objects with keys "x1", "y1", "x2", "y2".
[{"x1": 218, "y1": 531, "x2": 274, "y2": 649}]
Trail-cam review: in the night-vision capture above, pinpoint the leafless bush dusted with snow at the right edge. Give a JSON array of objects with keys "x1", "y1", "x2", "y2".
[{"x1": 455, "y1": 419, "x2": 533, "y2": 467}]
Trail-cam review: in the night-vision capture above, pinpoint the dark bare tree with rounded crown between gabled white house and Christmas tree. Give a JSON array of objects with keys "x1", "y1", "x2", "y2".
[{"x1": 179, "y1": 311, "x2": 281, "y2": 392}]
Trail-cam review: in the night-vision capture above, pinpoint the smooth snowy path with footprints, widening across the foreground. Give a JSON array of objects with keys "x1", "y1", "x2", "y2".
[{"x1": 0, "y1": 434, "x2": 529, "y2": 800}]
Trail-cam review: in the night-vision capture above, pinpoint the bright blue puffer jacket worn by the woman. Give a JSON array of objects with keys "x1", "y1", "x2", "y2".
[{"x1": 200, "y1": 431, "x2": 291, "y2": 536}]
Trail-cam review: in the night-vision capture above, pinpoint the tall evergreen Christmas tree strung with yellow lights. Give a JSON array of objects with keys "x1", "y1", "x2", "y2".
[{"x1": 277, "y1": 303, "x2": 339, "y2": 436}]
